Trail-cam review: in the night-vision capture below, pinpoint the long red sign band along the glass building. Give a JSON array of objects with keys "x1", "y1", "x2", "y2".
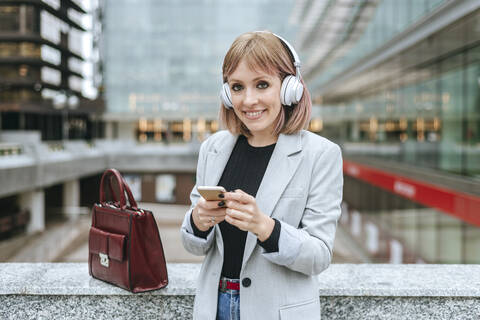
[{"x1": 343, "y1": 160, "x2": 480, "y2": 227}]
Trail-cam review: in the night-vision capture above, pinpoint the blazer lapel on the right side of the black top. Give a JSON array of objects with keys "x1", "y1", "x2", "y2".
[{"x1": 242, "y1": 133, "x2": 303, "y2": 268}]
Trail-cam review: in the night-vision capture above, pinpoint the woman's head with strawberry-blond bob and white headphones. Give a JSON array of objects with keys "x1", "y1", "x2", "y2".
[{"x1": 220, "y1": 32, "x2": 311, "y2": 145}]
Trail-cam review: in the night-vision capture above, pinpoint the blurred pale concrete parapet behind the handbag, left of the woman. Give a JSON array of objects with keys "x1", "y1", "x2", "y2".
[{"x1": 0, "y1": 132, "x2": 200, "y2": 197}]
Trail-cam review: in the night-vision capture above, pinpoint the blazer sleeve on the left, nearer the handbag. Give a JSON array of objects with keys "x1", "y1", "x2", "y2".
[{"x1": 180, "y1": 140, "x2": 215, "y2": 256}]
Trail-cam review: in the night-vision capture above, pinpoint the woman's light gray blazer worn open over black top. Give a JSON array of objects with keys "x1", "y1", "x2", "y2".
[{"x1": 181, "y1": 130, "x2": 343, "y2": 320}]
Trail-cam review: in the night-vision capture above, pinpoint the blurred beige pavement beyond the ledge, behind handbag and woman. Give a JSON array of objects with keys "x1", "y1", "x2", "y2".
[{"x1": 0, "y1": 203, "x2": 369, "y2": 263}]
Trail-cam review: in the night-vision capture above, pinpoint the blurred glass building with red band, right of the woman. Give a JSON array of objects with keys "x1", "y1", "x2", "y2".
[{"x1": 300, "y1": 0, "x2": 480, "y2": 263}]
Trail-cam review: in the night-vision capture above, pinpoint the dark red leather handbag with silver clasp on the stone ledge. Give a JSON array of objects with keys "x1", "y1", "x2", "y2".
[{"x1": 88, "y1": 169, "x2": 168, "y2": 292}]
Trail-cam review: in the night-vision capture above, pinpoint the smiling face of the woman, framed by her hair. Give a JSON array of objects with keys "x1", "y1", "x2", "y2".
[{"x1": 228, "y1": 60, "x2": 282, "y2": 139}]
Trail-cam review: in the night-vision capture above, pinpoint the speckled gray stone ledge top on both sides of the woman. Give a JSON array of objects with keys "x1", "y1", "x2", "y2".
[{"x1": 0, "y1": 263, "x2": 480, "y2": 297}]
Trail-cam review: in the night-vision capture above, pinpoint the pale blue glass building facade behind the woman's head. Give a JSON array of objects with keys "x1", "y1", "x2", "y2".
[{"x1": 103, "y1": 0, "x2": 295, "y2": 121}]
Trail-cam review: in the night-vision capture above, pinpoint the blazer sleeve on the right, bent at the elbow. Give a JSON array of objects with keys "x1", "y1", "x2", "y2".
[{"x1": 263, "y1": 143, "x2": 343, "y2": 275}]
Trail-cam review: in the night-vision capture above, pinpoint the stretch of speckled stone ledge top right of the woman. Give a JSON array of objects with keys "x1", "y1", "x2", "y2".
[{"x1": 318, "y1": 264, "x2": 480, "y2": 297}]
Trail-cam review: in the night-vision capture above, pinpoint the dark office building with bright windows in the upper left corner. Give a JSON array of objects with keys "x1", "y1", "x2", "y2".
[{"x1": 0, "y1": 0, "x2": 104, "y2": 140}]
